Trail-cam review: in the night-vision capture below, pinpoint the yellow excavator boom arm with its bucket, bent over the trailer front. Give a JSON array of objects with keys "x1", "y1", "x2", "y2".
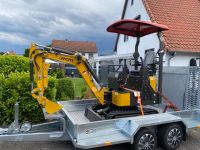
[{"x1": 29, "y1": 44, "x2": 107, "y2": 113}]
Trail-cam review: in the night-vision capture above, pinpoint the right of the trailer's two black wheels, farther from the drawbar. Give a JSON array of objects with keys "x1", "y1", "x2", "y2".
[{"x1": 158, "y1": 124, "x2": 183, "y2": 150}]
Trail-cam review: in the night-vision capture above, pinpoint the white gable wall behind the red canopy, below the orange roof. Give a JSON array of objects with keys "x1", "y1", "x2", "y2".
[{"x1": 117, "y1": 0, "x2": 159, "y2": 57}]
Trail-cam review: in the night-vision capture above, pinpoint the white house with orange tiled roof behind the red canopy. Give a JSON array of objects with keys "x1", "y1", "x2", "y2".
[{"x1": 114, "y1": 0, "x2": 200, "y2": 66}]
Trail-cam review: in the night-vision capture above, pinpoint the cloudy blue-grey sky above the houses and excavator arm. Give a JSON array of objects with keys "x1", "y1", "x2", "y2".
[{"x1": 0, "y1": 0, "x2": 124, "y2": 54}]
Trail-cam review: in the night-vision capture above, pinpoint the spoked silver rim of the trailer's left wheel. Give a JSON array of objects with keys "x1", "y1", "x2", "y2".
[{"x1": 138, "y1": 134, "x2": 155, "y2": 150}]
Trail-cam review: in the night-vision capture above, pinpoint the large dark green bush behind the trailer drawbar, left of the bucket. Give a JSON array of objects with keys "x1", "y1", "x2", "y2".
[{"x1": 0, "y1": 72, "x2": 44, "y2": 125}]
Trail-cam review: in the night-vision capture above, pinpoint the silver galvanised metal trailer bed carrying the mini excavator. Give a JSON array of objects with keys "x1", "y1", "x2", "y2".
[{"x1": 58, "y1": 99, "x2": 200, "y2": 149}]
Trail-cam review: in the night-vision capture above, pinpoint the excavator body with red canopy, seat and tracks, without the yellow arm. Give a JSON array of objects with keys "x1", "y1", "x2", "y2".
[{"x1": 85, "y1": 19, "x2": 168, "y2": 120}]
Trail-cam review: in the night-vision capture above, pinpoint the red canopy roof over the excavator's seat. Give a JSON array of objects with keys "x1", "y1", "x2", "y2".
[{"x1": 107, "y1": 19, "x2": 169, "y2": 37}]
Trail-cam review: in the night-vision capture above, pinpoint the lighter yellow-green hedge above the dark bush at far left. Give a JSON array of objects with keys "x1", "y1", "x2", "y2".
[{"x1": 0, "y1": 55, "x2": 29, "y2": 76}]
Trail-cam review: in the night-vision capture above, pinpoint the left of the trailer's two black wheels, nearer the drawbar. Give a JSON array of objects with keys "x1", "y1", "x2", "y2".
[{"x1": 131, "y1": 128, "x2": 157, "y2": 150}]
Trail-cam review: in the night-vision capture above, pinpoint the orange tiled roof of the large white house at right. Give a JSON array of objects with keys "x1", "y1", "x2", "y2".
[{"x1": 143, "y1": 0, "x2": 200, "y2": 52}]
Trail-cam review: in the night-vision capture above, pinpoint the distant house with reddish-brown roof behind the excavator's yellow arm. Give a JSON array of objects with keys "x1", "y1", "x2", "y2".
[{"x1": 51, "y1": 40, "x2": 98, "y2": 76}]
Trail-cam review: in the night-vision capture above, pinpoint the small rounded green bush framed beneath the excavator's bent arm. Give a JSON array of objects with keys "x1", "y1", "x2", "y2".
[{"x1": 56, "y1": 78, "x2": 74, "y2": 100}]
